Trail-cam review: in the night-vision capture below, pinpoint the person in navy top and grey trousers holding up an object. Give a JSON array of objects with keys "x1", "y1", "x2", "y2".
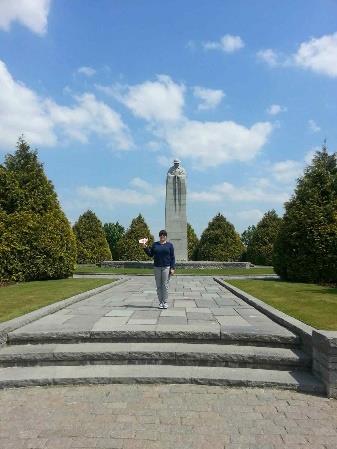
[{"x1": 143, "y1": 229, "x2": 175, "y2": 309}]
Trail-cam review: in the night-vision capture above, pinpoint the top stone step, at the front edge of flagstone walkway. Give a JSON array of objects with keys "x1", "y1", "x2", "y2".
[{"x1": 7, "y1": 324, "x2": 301, "y2": 347}]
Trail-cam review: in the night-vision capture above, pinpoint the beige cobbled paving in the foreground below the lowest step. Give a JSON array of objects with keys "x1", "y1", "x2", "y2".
[{"x1": 0, "y1": 385, "x2": 337, "y2": 449}]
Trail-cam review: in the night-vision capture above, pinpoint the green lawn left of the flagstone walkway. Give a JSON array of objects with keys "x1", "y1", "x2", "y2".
[{"x1": 0, "y1": 279, "x2": 111, "y2": 322}]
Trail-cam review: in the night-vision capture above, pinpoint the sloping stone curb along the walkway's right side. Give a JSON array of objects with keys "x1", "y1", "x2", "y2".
[{"x1": 213, "y1": 277, "x2": 317, "y2": 355}]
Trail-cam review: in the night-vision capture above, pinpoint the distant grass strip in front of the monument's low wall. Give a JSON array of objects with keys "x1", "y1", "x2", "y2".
[{"x1": 75, "y1": 265, "x2": 275, "y2": 276}]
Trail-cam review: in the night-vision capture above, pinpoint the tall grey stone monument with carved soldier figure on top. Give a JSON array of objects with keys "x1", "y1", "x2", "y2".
[{"x1": 165, "y1": 159, "x2": 187, "y2": 261}]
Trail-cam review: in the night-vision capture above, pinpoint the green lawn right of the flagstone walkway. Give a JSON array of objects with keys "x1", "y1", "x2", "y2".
[{"x1": 226, "y1": 279, "x2": 337, "y2": 330}]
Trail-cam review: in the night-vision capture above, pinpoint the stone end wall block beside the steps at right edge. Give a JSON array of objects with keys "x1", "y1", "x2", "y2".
[{"x1": 312, "y1": 330, "x2": 337, "y2": 398}]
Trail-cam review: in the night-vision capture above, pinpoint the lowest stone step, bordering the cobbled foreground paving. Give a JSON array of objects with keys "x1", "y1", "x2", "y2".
[{"x1": 0, "y1": 365, "x2": 325, "y2": 393}]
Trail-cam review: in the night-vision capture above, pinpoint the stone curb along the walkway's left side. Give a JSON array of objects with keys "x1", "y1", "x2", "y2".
[{"x1": 0, "y1": 278, "x2": 128, "y2": 347}]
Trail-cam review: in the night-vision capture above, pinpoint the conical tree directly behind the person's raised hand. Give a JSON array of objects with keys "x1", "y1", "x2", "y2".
[{"x1": 117, "y1": 214, "x2": 154, "y2": 260}]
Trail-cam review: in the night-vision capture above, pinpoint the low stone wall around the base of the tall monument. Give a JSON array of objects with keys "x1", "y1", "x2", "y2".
[{"x1": 98, "y1": 260, "x2": 251, "y2": 269}]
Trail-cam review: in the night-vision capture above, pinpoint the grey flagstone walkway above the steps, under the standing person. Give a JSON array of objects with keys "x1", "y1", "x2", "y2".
[{"x1": 9, "y1": 276, "x2": 292, "y2": 336}]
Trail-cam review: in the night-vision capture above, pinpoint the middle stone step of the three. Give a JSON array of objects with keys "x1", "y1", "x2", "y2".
[{"x1": 0, "y1": 342, "x2": 311, "y2": 370}]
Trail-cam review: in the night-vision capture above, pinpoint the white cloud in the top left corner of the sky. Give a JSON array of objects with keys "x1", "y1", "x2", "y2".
[{"x1": 0, "y1": 0, "x2": 51, "y2": 35}]
